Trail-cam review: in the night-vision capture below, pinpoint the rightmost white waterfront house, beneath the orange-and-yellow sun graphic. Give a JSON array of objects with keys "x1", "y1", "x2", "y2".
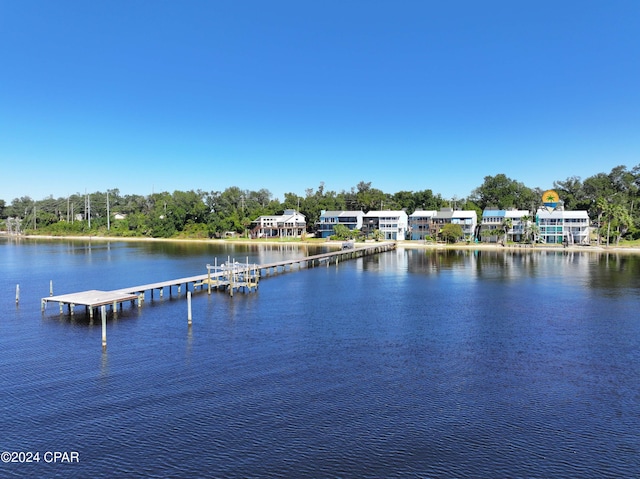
[{"x1": 536, "y1": 206, "x2": 589, "y2": 244}]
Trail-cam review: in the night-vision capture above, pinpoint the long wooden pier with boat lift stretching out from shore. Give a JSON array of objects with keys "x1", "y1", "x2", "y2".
[{"x1": 41, "y1": 242, "x2": 396, "y2": 318}]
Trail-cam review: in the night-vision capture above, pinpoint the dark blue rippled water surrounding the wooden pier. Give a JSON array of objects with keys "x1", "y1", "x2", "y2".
[{"x1": 0, "y1": 240, "x2": 640, "y2": 478}]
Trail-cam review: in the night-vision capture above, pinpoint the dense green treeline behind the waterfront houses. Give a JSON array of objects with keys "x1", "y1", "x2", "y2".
[{"x1": 0, "y1": 165, "x2": 640, "y2": 238}]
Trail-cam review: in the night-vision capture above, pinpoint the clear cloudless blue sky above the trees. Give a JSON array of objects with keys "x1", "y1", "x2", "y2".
[{"x1": 0, "y1": 0, "x2": 640, "y2": 203}]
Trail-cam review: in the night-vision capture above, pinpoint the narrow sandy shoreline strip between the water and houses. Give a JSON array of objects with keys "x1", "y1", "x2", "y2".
[{"x1": 5, "y1": 235, "x2": 640, "y2": 254}]
